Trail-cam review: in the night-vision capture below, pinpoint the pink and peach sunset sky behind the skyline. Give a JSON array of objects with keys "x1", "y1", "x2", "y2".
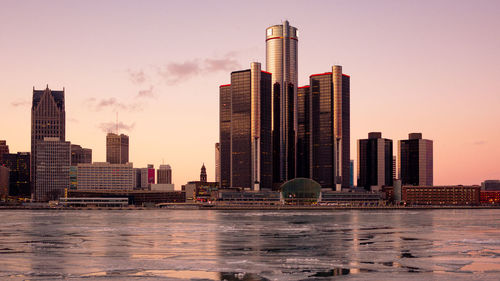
[{"x1": 0, "y1": 0, "x2": 500, "y2": 189}]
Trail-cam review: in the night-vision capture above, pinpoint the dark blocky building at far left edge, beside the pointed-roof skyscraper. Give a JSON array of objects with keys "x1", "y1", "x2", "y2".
[{"x1": 0, "y1": 152, "x2": 31, "y2": 198}]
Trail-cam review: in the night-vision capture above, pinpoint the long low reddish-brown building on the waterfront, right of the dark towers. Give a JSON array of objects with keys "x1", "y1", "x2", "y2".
[{"x1": 402, "y1": 185, "x2": 481, "y2": 205}]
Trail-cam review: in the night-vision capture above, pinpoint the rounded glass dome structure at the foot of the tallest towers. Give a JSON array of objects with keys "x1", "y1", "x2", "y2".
[{"x1": 281, "y1": 178, "x2": 321, "y2": 204}]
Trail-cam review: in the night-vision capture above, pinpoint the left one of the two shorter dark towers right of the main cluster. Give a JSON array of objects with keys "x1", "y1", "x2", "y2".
[{"x1": 358, "y1": 132, "x2": 393, "y2": 190}]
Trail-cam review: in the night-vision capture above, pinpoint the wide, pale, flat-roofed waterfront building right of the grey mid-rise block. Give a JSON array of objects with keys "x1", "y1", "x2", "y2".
[{"x1": 77, "y1": 162, "x2": 134, "y2": 190}]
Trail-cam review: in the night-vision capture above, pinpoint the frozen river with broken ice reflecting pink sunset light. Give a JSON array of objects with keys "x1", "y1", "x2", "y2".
[{"x1": 0, "y1": 209, "x2": 500, "y2": 281}]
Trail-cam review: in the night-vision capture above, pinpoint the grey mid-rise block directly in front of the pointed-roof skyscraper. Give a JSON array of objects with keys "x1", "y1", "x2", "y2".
[{"x1": 34, "y1": 138, "x2": 71, "y2": 201}]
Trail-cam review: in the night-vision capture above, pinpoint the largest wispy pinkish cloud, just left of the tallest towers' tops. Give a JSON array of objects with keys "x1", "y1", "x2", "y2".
[{"x1": 157, "y1": 54, "x2": 240, "y2": 84}]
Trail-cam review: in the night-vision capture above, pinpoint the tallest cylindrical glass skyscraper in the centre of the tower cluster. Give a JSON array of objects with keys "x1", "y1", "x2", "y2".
[{"x1": 266, "y1": 21, "x2": 298, "y2": 183}]
